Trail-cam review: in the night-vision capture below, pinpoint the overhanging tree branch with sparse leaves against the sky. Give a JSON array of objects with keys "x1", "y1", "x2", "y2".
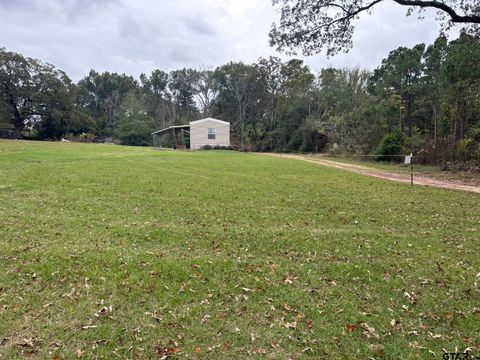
[{"x1": 270, "y1": 0, "x2": 480, "y2": 55}]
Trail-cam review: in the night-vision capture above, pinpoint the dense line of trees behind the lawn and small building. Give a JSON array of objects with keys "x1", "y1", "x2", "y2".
[{"x1": 0, "y1": 32, "x2": 480, "y2": 164}]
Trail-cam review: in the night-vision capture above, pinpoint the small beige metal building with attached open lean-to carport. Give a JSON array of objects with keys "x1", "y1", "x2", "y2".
[{"x1": 152, "y1": 118, "x2": 230, "y2": 150}]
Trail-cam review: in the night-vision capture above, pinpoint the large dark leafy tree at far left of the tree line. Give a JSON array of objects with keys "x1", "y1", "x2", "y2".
[{"x1": 0, "y1": 49, "x2": 93, "y2": 139}]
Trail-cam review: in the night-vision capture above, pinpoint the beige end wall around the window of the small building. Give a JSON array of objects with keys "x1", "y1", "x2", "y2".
[{"x1": 190, "y1": 120, "x2": 230, "y2": 150}]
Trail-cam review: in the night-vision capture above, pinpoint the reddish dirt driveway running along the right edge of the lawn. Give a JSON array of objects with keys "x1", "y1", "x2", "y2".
[{"x1": 261, "y1": 153, "x2": 480, "y2": 193}]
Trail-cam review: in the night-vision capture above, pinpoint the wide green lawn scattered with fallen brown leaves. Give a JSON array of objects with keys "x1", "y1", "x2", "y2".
[{"x1": 0, "y1": 141, "x2": 480, "y2": 359}]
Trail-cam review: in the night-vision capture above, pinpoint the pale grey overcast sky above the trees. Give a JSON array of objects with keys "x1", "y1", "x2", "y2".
[{"x1": 0, "y1": 0, "x2": 448, "y2": 81}]
